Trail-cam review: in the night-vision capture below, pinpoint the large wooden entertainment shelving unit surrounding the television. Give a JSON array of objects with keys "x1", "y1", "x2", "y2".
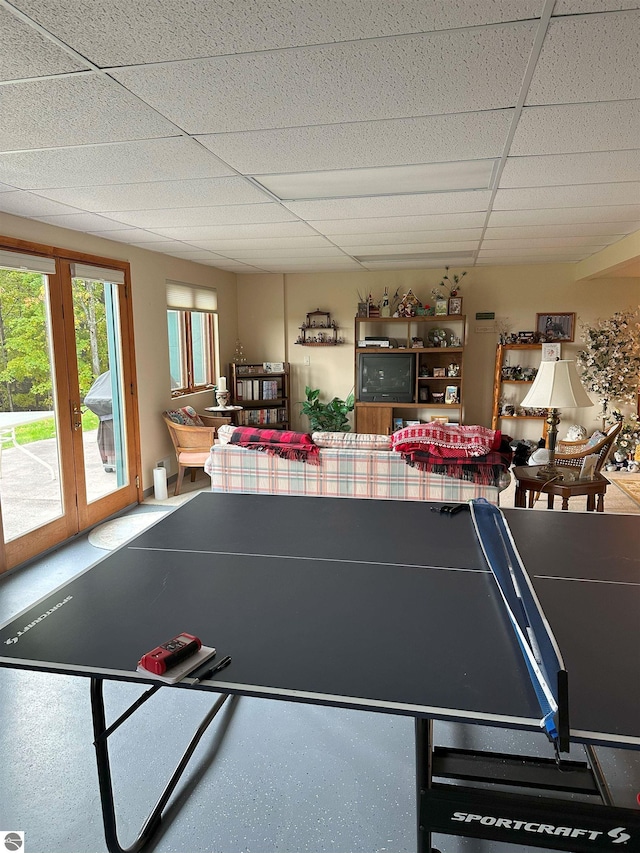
[{"x1": 355, "y1": 314, "x2": 466, "y2": 434}]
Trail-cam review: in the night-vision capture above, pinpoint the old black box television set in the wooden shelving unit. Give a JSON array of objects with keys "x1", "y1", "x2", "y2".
[{"x1": 358, "y1": 352, "x2": 416, "y2": 403}]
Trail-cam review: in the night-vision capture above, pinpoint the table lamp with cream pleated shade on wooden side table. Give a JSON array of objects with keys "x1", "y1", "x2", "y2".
[{"x1": 520, "y1": 360, "x2": 593, "y2": 480}]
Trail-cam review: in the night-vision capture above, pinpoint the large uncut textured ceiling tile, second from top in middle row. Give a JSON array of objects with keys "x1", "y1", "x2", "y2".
[{"x1": 112, "y1": 22, "x2": 535, "y2": 134}]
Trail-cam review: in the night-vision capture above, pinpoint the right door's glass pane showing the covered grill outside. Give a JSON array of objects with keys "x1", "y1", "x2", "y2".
[{"x1": 72, "y1": 270, "x2": 129, "y2": 503}]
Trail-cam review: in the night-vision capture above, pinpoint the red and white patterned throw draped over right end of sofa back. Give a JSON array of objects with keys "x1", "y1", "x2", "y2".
[{"x1": 391, "y1": 423, "x2": 502, "y2": 459}]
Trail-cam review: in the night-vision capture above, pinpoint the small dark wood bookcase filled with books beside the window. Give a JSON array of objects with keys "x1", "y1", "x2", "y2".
[{"x1": 229, "y1": 362, "x2": 290, "y2": 429}]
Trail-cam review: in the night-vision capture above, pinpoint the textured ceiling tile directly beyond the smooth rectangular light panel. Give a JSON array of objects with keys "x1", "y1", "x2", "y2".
[{"x1": 285, "y1": 190, "x2": 491, "y2": 221}]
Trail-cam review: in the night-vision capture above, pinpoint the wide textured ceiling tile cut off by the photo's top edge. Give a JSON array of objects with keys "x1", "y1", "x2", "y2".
[{"x1": 14, "y1": 0, "x2": 541, "y2": 66}]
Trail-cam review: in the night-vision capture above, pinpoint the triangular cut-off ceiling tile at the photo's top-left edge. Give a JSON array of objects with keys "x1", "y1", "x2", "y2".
[{"x1": 0, "y1": 6, "x2": 89, "y2": 80}]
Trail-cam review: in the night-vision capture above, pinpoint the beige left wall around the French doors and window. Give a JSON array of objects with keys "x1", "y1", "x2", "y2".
[{"x1": 0, "y1": 213, "x2": 238, "y2": 489}]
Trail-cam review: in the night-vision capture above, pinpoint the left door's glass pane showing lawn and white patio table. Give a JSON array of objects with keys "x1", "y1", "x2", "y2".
[{"x1": 0, "y1": 268, "x2": 63, "y2": 542}]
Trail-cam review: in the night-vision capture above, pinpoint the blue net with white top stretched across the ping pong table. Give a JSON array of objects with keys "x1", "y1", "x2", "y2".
[{"x1": 469, "y1": 498, "x2": 569, "y2": 760}]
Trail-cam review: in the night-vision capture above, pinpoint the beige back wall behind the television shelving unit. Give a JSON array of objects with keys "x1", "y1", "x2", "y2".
[{"x1": 238, "y1": 264, "x2": 640, "y2": 438}]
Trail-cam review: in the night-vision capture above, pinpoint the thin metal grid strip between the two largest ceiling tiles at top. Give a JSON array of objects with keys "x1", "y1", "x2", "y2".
[{"x1": 96, "y1": 18, "x2": 544, "y2": 73}]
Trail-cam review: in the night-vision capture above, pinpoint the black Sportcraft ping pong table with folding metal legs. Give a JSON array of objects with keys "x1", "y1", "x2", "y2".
[{"x1": 0, "y1": 493, "x2": 640, "y2": 853}]
